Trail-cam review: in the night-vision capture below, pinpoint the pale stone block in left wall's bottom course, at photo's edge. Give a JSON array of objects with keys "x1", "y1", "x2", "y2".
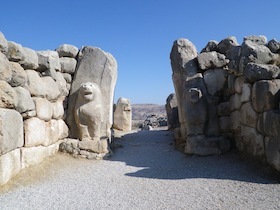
[{"x1": 0, "y1": 149, "x2": 21, "y2": 186}]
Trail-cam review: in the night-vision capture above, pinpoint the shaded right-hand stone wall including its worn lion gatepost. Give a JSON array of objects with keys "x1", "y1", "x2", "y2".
[{"x1": 166, "y1": 36, "x2": 280, "y2": 171}]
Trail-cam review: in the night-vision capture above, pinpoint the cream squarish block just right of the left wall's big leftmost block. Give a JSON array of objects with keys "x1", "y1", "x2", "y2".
[{"x1": 24, "y1": 117, "x2": 47, "y2": 147}]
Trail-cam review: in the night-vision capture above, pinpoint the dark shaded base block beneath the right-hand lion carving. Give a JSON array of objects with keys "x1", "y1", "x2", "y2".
[{"x1": 185, "y1": 135, "x2": 230, "y2": 156}]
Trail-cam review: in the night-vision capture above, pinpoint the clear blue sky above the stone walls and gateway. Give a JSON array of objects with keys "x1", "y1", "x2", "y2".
[{"x1": 0, "y1": 0, "x2": 280, "y2": 104}]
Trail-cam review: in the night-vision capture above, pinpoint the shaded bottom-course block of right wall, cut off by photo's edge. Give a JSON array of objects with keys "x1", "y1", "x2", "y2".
[{"x1": 265, "y1": 136, "x2": 280, "y2": 171}]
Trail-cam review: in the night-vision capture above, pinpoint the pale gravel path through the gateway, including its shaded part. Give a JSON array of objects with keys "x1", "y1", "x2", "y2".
[{"x1": 0, "y1": 130, "x2": 280, "y2": 209}]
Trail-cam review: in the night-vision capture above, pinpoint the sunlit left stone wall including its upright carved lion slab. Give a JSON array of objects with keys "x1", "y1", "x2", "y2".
[{"x1": 0, "y1": 32, "x2": 117, "y2": 186}]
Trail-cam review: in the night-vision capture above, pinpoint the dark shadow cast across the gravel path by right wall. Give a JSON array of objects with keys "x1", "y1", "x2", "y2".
[{"x1": 110, "y1": 130, "x2": 280, "y2": 184}]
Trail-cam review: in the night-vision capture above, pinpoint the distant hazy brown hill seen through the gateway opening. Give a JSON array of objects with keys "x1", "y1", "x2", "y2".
[{"x1": 132, "y1": 104, "x2": 166, "y2": 120}]
